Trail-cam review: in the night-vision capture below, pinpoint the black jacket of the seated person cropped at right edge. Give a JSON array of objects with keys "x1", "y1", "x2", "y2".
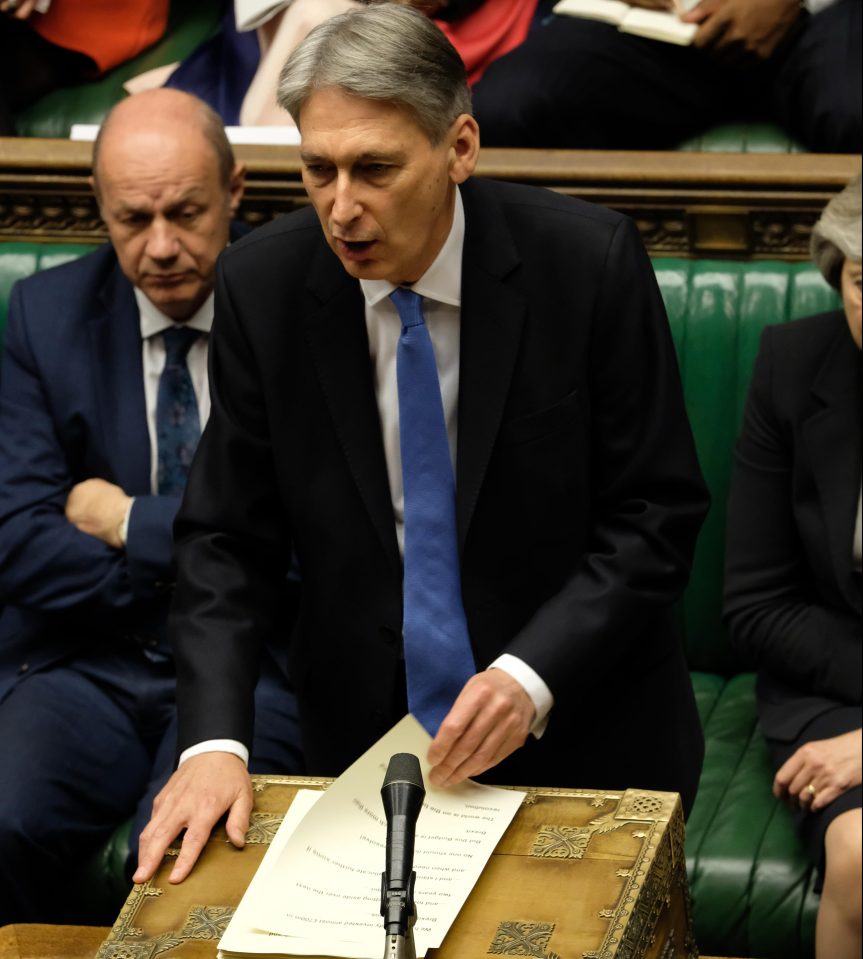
[{"x1": 725, "y1": 311, "x2": 863, "y2": 742}]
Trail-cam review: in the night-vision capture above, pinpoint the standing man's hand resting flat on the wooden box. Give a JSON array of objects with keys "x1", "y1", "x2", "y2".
[{"x1": 132, "y1": 752, "x2": 252, "y2": 882}]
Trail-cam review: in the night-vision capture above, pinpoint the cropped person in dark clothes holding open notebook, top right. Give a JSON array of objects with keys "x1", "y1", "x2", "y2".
[{"x1": 474, "y1": 0, "x2": 863, "y2": 153}]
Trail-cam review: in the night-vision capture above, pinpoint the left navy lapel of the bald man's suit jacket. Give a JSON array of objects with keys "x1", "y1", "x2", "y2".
[{"x1": 88, "y1": 265, "x2": 150, "y2": 495}]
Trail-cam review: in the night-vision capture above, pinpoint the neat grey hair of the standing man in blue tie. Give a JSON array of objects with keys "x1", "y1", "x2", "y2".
[{"x1": 276, "y1": 3, "x2": 471, "y2": 145}]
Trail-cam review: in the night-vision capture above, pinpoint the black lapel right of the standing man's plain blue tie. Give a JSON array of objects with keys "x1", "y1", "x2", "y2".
[{"x1": 456, "y1": 181, "x2": 527, "y2": 549}]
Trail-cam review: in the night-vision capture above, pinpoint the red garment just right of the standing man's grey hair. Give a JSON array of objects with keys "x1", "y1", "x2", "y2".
[{"x1": 435, "y1": 0, "x2": 537, "y2": 86}]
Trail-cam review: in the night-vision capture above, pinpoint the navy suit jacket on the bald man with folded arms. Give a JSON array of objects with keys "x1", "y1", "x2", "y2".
[{"x1": 0, "y1": 244, "x2": 179, "y2": 698}]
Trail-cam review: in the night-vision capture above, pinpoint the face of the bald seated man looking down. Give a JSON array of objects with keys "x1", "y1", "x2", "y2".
[{"x1": 98, "y1": 129, "x2": 243, "y2": 322}]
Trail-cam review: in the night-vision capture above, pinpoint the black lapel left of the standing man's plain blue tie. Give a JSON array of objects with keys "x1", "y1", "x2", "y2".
[{"x1": 304, "y1": 241, "x2": 401, "y2": 569}]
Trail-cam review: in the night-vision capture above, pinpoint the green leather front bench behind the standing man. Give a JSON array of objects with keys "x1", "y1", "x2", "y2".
[{"x1": 0, "y1": 243, "x2": 838, "y2": 959}]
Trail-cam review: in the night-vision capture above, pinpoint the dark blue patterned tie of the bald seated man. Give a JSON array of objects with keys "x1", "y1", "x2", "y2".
[{"x1": 156, "y1": 326, "x2": 201, "y2": 496}]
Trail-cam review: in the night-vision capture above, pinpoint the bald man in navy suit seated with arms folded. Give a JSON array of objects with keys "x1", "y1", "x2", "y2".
[{"x1": 0, "y1": 91, "x2": 298, "y2": 924}]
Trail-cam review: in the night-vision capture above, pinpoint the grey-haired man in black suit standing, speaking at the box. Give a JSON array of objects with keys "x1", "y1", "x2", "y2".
[{"x1": 136, "y1": 4, "x2": 707, "y2": 881}]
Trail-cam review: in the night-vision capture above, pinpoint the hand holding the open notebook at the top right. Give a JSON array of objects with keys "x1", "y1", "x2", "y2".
[{"x1": 680, "y1": 0, "x2": 801, "y2": 60}]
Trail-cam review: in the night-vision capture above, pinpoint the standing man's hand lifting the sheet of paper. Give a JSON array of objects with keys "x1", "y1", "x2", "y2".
[{"x1": 428, "y1": 669, "x2": 536, "y2": 786}]
